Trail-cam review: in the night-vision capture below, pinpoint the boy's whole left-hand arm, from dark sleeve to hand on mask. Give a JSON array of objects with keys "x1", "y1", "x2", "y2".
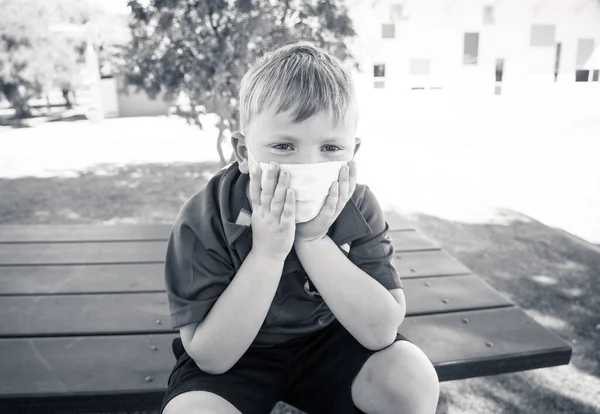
[{"x1": 165, "y1": 163, "x2": 296, "y2": 374}]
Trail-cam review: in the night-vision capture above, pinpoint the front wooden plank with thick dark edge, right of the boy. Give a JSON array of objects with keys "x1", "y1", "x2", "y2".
[{"x1": 400, "y1": 306, "x2": 572, "y2": 381}]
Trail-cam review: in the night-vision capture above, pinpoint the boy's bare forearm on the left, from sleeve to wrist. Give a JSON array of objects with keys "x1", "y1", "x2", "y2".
[{"x1": 180, "y1": 251, "x2": 284, "y2": 374}]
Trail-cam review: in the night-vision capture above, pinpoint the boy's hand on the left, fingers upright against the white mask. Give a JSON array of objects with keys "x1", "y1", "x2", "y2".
[{"x1": 250, "y1": 163, "x2": 296, "y2": 260}]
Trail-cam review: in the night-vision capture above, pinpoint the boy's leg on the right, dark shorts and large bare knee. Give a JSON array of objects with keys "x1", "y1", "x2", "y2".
[{"x1": 283, "y1": 320, "x2": 438, "y2": 414}]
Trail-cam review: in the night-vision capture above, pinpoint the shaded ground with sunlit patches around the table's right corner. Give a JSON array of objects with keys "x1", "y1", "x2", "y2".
[{"x1": 398, "y1": 215, "x2": 600, "y2": 414}]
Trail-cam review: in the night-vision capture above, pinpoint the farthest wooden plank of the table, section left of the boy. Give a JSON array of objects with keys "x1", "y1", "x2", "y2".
[{"x1": 0, "y1": 224, "x2": 171, "y2": 243}]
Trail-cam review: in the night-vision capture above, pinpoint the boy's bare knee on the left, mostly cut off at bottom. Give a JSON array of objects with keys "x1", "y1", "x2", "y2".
[{"x1": 162, "y1": 391, "x2": 241, "y2": 414}]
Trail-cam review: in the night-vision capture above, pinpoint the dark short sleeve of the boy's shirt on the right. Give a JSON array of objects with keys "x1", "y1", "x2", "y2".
[{"x1": 348, "y1": 186, "x2": 403, "y2": 290}]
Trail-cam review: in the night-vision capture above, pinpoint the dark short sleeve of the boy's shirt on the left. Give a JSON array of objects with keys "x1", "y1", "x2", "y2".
[{"x1": 165, "y1": 217, "x2": 235, "y2": 329}]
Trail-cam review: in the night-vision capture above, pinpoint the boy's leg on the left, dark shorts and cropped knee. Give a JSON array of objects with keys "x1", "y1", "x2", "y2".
[{"x1": 159, "y1": 342, "x2": 288, "y2": 414}]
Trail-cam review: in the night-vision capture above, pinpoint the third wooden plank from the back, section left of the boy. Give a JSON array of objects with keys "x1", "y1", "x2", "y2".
[{"x1": 0, "y1": 263, "x2": 165, "y2": 296}]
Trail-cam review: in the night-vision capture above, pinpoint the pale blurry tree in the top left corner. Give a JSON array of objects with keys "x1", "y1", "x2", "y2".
[{"x1": 0, "y1": 0, "x2": 129, "y2": 118}]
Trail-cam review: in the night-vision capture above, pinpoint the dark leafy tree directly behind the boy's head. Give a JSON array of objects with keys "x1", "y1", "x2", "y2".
[{"x1": 126, "y1": 0, "x2": 358, "y2": 164}]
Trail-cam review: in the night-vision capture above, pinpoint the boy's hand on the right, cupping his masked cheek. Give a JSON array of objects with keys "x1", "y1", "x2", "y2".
[{"x1": 295, "y1": 161, "x2": 356, "y2": 242}]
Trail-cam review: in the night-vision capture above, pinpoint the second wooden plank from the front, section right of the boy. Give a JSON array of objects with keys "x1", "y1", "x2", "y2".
[{"x1": 403, "y1": 274, "x2": 513, "y2": 316}]
